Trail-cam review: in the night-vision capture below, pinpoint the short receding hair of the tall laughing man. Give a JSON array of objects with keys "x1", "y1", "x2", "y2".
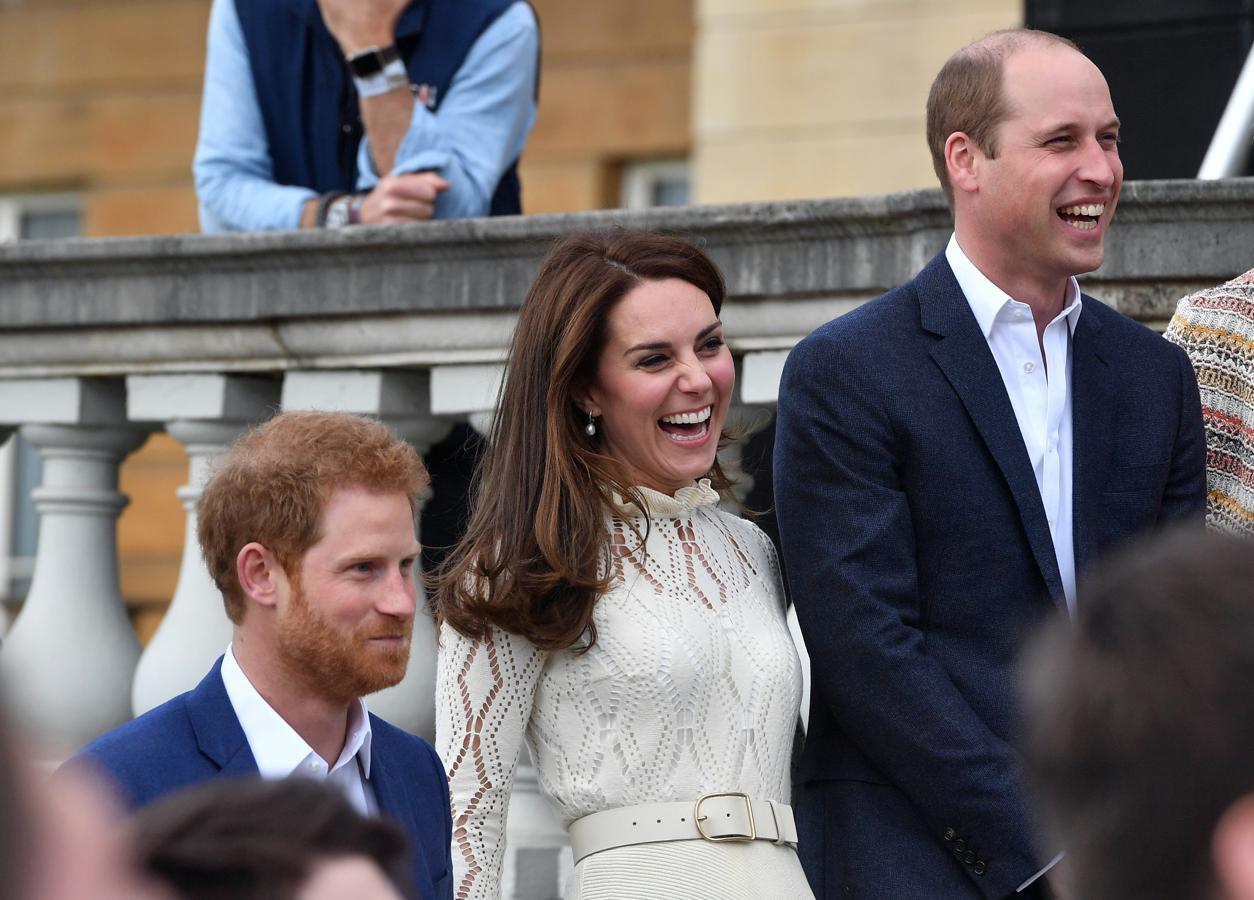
[{"x1": 928, "y1": 28, "x2": 1080, "y2": 204}]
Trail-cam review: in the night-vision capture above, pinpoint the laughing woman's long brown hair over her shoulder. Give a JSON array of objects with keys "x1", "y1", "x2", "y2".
[{"x1": 433, "y1": 229, "x2": 729, "y2": 651}]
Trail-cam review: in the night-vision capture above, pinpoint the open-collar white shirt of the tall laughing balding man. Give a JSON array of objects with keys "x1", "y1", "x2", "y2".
[{"x1": 946, "y1": 234, "x2": 1082, "y2": 613}]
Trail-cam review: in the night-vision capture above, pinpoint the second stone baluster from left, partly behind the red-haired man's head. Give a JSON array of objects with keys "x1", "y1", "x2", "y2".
[{"x1": 127, "y1": 375, "x2": 278, "y2": 716}]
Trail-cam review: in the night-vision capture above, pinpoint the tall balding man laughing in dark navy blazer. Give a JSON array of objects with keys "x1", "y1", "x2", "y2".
[{"x1": 775, "y1": 30, "x2": 1205, "y2": 900}]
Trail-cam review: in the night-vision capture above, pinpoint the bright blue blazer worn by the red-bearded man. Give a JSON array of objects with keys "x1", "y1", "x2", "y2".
[{"x1": 71, "y1": 657, "x2": 453, "y2": 900}]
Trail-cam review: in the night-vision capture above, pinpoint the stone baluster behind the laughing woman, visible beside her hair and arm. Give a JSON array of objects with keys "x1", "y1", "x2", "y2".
[{"x1": 448, "y1": 383, "x2": 571, "y2": 900}]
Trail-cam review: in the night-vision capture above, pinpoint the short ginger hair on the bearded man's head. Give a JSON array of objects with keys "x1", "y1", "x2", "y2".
[{"x1": 197, "y1": 412, "x2": 430, "y2": 624}]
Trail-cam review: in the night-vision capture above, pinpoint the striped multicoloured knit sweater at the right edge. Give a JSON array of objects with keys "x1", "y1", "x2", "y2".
[{"x1": 1166, "y1": 269, "x2": 1254, "y2": 536}]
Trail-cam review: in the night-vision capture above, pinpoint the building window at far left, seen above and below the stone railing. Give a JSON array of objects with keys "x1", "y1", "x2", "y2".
[{"x1": 0, "y1": 194, "x2": 83, "y2": 632}]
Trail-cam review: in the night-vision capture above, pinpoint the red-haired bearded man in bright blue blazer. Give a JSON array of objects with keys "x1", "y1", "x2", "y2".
[{"x1": 68, "y1": 412, "x2": 451, "y2": 897}]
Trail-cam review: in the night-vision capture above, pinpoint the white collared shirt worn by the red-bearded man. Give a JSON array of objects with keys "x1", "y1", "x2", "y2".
[{"x1": 222, "y1": 647, "x2": 379, "y2": 815}]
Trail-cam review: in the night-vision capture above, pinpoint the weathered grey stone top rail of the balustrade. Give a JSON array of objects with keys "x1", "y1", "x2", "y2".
[{"x1": 0, "y1": 179, "x2": 1254, "y2": 377}]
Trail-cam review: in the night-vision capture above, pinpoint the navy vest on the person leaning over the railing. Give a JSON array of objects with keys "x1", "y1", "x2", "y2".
[{"x1": 234, "y1": 0, "x2": 522, "y2": 216}]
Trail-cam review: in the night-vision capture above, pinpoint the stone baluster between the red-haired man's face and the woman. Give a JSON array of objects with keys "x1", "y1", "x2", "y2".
[{"x1": 282, "y1": 370, "x2": 453, "y2": 741}]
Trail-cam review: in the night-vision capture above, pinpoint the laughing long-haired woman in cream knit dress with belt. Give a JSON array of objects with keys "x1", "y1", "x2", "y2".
[{"x1": 436, "y1": 231, "x2": 811, "y2": 900}]
